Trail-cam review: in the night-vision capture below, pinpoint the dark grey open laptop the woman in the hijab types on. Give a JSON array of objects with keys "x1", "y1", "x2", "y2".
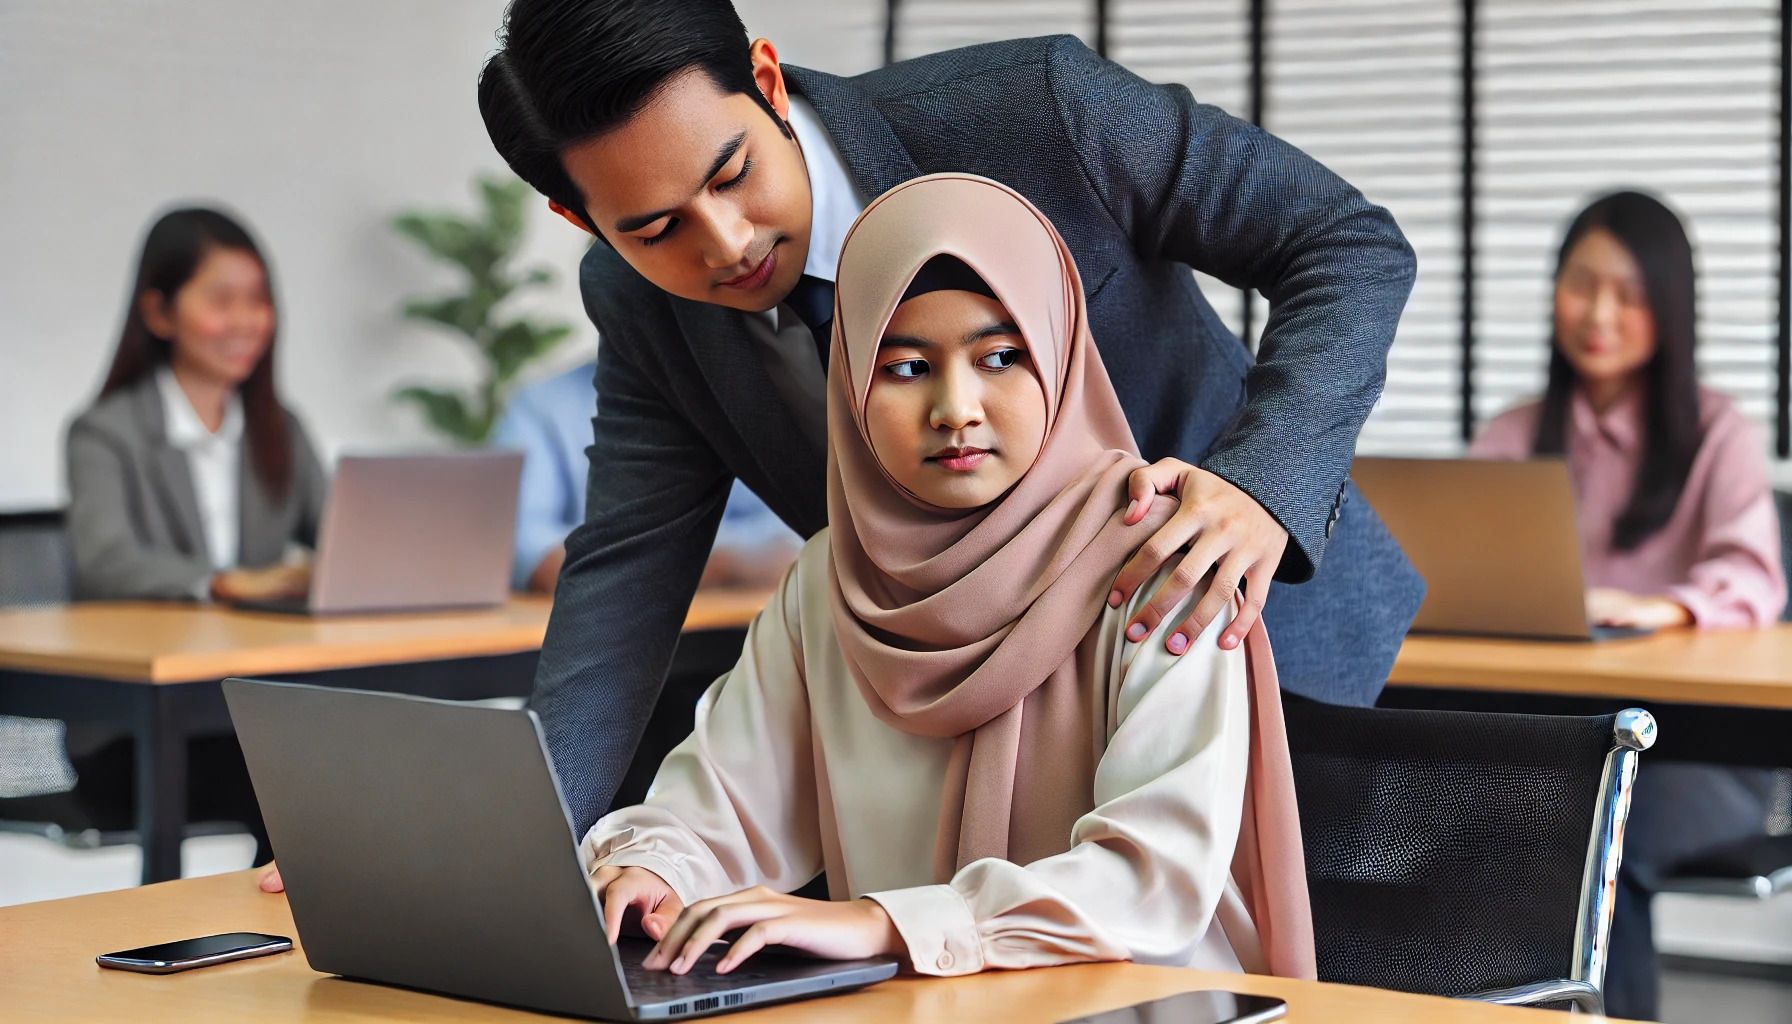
[{"x1": 224, "y1": 680, "x2": 896, "y2": 1020}]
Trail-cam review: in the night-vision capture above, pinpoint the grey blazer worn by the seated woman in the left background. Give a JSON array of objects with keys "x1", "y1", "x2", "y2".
[{"x1": 66, "y1": 375, "x2": 326, "y2": 599}]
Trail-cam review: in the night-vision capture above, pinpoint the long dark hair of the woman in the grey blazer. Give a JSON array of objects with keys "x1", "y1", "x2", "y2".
[{"x1": 100, "y1": 208, "x2": 292, "y2": 499}]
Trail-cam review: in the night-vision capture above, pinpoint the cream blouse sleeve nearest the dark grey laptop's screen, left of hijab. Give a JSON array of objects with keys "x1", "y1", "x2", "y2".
[{"x1": 582, "y1": 563, "x2": 823, "y2": 906}]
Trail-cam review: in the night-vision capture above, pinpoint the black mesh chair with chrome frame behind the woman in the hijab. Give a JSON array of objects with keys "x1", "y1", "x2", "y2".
[{"x1": 1287, "y1": 698, "x2": 1656, "y2": 1013}]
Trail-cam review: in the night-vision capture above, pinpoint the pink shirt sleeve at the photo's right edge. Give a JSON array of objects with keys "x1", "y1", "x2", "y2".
[{"x1": 1668, "y1": 412, "x2": 1787, "y2": 629}]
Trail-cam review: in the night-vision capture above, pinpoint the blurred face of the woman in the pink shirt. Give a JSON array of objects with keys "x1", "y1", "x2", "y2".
[{"x1": 1555, "y1": 228, "x2": 1656, "y2": 384}]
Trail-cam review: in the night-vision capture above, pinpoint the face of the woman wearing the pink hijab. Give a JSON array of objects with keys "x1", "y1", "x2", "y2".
[{"x1": 866, "y1": 291, "x2": 1045, "y2": 509}]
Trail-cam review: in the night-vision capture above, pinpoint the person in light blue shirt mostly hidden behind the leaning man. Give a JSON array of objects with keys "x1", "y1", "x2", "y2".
[{"x1": 491, "y1": 362, "x2": 801, "y2": 594}]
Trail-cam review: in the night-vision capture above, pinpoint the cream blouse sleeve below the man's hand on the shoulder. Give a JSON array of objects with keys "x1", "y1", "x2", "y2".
[{"x1": 869, "y1": 585, "x2": 1251, "y2": 976}]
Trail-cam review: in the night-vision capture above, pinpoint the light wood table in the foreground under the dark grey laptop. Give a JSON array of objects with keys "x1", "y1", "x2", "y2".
[{"x1": 0, "y1": 872, "x2": 1586, "y2": 1024}]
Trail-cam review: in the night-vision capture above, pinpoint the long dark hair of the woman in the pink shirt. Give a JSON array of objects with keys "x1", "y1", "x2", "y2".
[{"x1": 1532, "y1": 192, "x2": 1699, "y2": 551}]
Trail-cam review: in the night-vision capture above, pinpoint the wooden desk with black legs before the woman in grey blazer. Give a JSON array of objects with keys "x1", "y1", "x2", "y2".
[{"x1": 0, "y1": 590, "x2": 769, "y2": 882}]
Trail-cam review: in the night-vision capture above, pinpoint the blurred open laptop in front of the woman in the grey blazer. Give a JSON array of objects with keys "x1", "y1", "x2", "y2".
[{"x1": 235, "y1": 452, "x2": 523, "y2": 615}]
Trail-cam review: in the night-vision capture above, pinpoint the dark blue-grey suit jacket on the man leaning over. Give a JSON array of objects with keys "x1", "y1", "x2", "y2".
[{"x1": 534, "y1": 36, "x2": 1423, "y2": 830}]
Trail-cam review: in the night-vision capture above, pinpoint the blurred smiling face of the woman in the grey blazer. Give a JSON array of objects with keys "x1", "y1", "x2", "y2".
[{"x1": 142, "y1": 249, "x2": 274, "y2": 387}]
